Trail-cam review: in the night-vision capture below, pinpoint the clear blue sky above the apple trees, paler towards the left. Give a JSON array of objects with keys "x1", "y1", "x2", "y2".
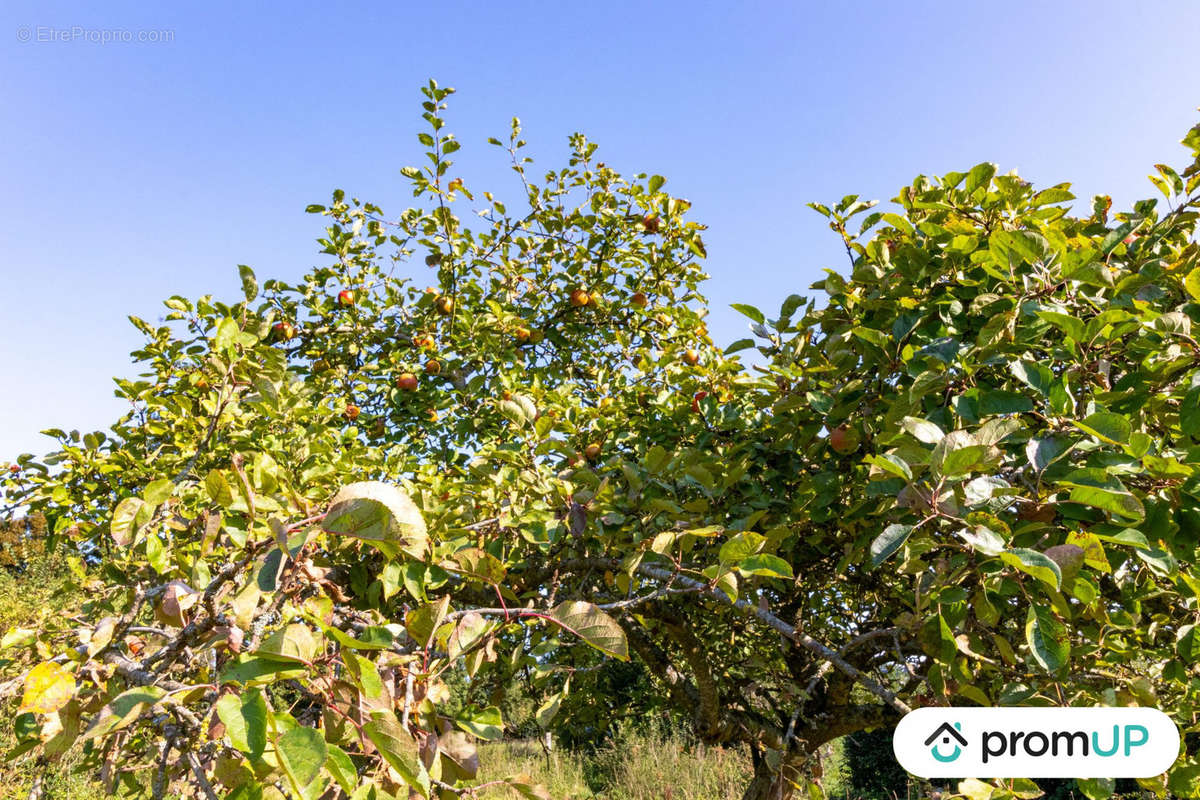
[{"x1": 0, "y1": 0, "x2": 1200, "y2": 461}]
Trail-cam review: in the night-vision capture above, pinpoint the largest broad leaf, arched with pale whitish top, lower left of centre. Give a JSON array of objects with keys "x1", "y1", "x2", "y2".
[{"x1": 320, "y1": 481, "x2": 430, "y2": 559}]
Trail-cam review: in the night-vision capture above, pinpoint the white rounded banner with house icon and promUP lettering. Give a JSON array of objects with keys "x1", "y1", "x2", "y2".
[{"x1": 892, "y1": 706, "x2": 1180, "y2": 778}]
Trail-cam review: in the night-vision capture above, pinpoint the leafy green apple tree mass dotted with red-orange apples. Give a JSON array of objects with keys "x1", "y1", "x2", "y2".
[{"x1": 7, "y1": 83, "x2": 1200, "y2": 800}]
